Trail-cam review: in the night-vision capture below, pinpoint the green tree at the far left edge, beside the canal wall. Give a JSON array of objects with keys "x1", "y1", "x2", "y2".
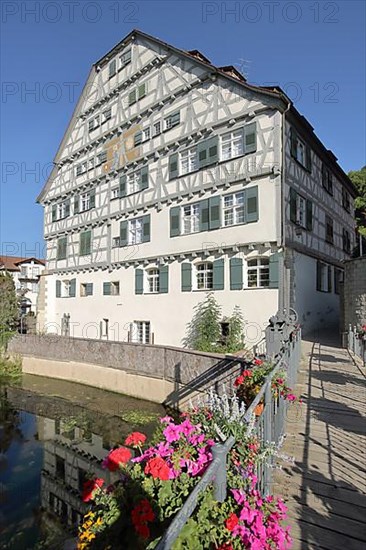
[{"x1": 0, "y1": 273, "x2": 19, "y2": 344}]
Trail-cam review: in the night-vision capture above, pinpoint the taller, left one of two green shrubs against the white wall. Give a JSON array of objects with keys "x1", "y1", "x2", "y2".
[{"x1": 183, "y1": 292, "x2": 221, "y2": 352}]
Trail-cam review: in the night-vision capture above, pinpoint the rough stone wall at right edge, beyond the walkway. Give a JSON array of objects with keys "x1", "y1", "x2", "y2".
[{"x1": 341, "y1": 256, "x2": 366, "y2": 331}]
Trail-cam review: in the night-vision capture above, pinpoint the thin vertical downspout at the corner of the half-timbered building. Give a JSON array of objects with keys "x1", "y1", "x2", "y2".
[{"x1": 278, "y1": 101, "x2": 291, "y2": 312}]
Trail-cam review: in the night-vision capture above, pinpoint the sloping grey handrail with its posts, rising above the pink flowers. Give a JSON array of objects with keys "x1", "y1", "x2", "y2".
[{"x1": 156, "y1": 332, "x2": 301, "y2": 550}]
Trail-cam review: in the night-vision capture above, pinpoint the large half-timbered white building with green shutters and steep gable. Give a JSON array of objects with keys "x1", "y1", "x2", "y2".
[{"x1": 38, "y1": 30, "x2": 356, "y2": 346}]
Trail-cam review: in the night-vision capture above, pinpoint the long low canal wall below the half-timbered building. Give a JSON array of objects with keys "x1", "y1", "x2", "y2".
[{"x1": 9, "y1": 334, "x2": 239, "y2": 406}]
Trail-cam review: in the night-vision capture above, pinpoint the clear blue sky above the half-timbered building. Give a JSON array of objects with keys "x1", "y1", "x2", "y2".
[{"x1": 0, "y1": 0, "x2": 365, "y2": 256}]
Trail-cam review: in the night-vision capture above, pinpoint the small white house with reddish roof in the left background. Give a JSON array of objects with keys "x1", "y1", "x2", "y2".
[{"x1": 0, "y1": 256, "x2": 45, "y2": 315}]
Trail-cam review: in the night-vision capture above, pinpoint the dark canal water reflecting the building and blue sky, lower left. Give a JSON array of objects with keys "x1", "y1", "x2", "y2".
[{"x1": 0, "y1": 375, "x2": 163, "y2": 550}]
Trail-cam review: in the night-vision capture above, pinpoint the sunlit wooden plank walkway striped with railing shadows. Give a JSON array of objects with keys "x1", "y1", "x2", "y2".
[{"x1": 273, "y1": 338, "x2": 366, "y2": 550}]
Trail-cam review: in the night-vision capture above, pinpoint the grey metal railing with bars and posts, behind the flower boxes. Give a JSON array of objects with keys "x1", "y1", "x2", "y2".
[{"x1": 156, "y1": 326, "x2": 301, "y2": 550}]
